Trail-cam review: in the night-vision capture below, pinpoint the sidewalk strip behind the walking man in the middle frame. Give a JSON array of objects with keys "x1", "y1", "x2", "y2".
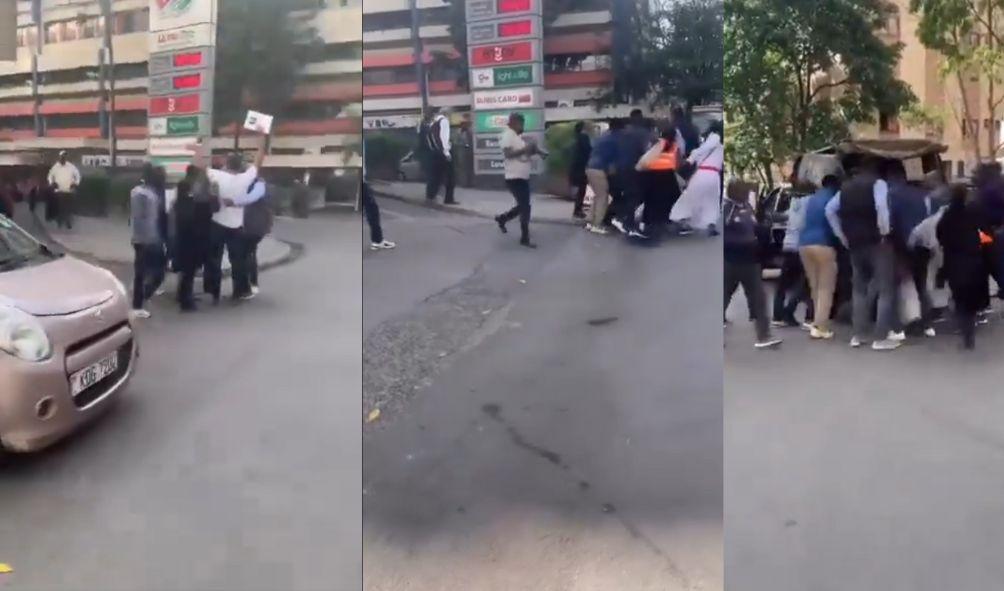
[{"x1": 370, "y1": 181, "x2": 583, "y2": 226}]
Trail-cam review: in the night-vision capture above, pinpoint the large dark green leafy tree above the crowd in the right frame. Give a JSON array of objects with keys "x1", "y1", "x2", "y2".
[{"x1": 724, "y1": 0, "x2": 916, "y2": 185}]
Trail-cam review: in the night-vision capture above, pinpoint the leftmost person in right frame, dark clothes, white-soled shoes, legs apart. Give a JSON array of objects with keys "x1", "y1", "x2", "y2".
[{"x1": 723, "y1": 177, "x2": 781, "y2": 349}]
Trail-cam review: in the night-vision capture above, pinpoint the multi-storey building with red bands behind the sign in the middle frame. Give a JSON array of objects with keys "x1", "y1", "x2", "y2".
[{"x1": 362, "y1": 0, "x2": 630, "y2": 128}]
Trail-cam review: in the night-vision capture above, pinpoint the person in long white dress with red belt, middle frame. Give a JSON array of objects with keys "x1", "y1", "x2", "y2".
[{"x1": 670, "y1": 121, "x2": 725, "y2": 234}]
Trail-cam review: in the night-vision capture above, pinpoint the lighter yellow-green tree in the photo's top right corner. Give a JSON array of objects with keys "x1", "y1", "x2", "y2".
[{"x1": 910, "y1": 0, "x2": 1004, "y2": 161}]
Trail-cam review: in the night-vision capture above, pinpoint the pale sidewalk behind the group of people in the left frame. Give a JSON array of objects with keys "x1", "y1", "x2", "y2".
[{"x1": 39, "y1": 210, "x2": 292, "y2": 271}]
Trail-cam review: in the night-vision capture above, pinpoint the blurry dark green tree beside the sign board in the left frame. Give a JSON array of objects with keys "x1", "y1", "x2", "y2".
[{"x1": 213, "y1": 0, "x2": 323, "y2": 150}]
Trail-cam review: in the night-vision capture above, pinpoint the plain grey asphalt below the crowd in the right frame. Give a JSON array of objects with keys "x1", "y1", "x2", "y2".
[{"x1": 725, "y1": 284, "x2": 1004, "y2": 591}]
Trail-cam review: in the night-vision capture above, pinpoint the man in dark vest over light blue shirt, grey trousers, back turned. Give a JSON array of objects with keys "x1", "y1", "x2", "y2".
[{"x1": 826, "y1": 161, "x2": 903, "y2": 351}]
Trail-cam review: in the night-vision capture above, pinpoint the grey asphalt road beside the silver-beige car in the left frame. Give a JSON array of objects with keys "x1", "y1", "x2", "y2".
[{"x1": 0, "y1": 214, "x2": 361, "y2": 591}]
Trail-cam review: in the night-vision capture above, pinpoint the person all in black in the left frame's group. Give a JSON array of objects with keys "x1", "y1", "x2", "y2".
[{"x1": 175, "y1": 165, "x2": 220, "y2": 312}]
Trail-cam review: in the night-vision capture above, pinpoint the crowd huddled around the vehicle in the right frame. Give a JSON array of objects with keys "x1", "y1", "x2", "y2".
[{"x1": 724, "y1": 158, "x2": 1004, "y2": 351}]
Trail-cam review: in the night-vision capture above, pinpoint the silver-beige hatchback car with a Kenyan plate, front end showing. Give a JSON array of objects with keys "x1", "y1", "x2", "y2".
[{"x1": 0, "y1": 216, "x2": 139, "y2": 453}]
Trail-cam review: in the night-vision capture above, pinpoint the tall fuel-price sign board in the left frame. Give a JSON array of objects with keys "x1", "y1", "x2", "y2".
[{"x1": 146, "y1": 0, "x2": 217, "y2": 178}]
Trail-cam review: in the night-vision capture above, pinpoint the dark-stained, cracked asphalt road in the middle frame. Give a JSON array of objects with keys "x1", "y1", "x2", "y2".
[{"x1": 363, "y1": 201, "x2": 723, "y2": 591}]
